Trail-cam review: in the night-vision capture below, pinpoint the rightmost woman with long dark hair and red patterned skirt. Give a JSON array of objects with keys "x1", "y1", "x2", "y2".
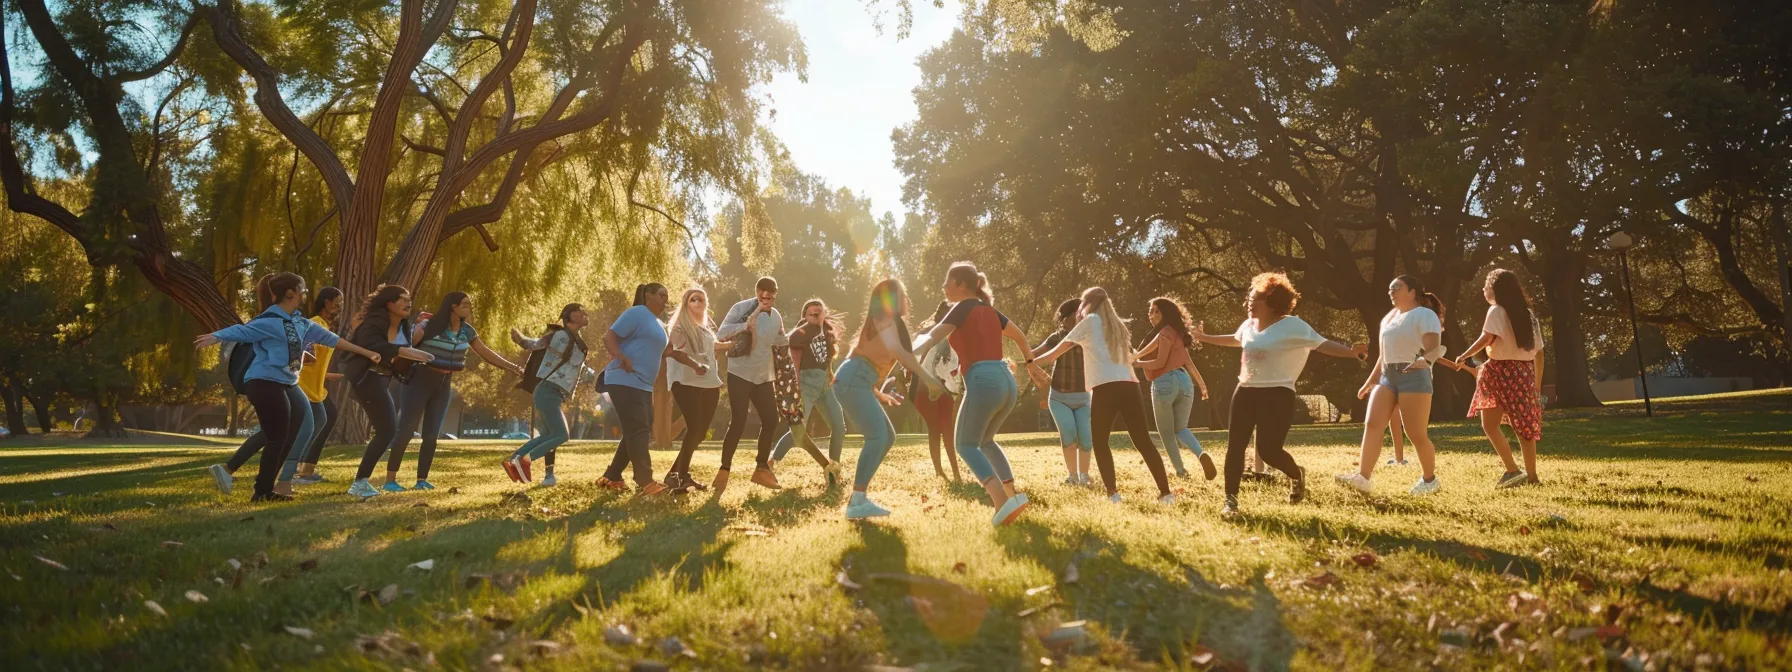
[{"x1": 1457, "y1": 269, "x2": 1543, "y2": 487}]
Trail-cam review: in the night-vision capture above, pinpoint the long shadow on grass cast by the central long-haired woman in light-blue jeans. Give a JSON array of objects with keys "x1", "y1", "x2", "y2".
[{"x1": 840, "y1": 523, "x2": 1032, "y2": 670}]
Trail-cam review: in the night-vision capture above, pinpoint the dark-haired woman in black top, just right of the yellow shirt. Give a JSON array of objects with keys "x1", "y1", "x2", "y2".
[{"x1": 342, "y1": 285, "x2": 434, "y2": 498}]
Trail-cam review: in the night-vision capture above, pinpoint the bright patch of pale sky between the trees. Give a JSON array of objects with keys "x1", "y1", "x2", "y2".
[{"x1": 765, "y1": 0, "x2": 959, "y2": 220}]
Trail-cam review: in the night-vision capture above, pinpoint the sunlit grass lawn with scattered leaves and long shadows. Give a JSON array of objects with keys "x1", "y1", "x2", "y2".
[{"x1": 0, "y1": 392, "x2": 1792, "y2": 670}]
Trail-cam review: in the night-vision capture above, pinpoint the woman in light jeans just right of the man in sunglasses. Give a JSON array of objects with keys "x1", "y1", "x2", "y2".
[{"x1": 772, "y1": 299, "x2": 852, "y2": 487}]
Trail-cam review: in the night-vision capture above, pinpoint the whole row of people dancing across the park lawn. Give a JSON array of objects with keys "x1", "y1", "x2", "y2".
[{"x1": 195, "y1": 263, "x2": 1543, "y2": 525}]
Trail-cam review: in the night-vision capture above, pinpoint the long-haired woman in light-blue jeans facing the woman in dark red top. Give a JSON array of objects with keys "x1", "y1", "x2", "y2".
[{"x1": 833, "y1": 278, "x2": 941, "y2": 520}]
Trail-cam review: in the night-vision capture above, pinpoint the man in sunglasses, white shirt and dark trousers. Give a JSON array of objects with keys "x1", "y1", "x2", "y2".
[{"x1": 715, "y1": 278, "x2": 788, "y2": 489}]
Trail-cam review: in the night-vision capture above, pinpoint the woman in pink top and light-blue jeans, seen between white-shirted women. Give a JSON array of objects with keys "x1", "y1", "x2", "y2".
[{"x1": 1138, "y1": 296, "x2": 1219, "y2": 480}]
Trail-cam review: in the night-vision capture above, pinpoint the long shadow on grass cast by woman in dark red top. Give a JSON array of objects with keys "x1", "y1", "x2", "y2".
[{"x1": 998, "y1": 520, "x2": 1296, "y2": 670}]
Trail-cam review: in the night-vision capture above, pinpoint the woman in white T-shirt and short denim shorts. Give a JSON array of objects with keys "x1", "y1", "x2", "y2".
[{"x1": 1337, "y1": 276, "x2": 1444, "y2": 495}]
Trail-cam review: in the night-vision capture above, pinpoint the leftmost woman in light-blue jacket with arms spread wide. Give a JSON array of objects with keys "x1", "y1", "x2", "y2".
[{"x1": 194, "y1": 272, "x2": 380, "y2": 502}]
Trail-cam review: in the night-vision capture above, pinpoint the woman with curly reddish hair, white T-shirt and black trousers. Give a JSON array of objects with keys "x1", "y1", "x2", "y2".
[{"x1": 1192, "y1": 272, "x2": 1369, "y2": 518}]
